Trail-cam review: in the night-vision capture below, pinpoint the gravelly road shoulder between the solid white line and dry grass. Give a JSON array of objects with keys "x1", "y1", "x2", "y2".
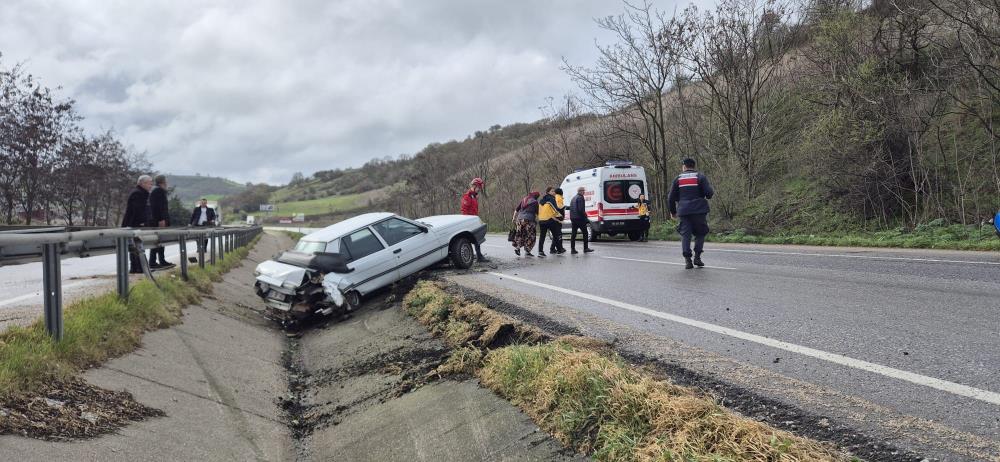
[{"x1": 445, "y1": 274, "x2": 1000, "y2": 460}]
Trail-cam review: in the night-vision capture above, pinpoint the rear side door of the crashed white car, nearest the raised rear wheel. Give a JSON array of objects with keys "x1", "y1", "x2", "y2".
[{"x1": 372, "y1": 217, "x2": 447, "y2": 279}]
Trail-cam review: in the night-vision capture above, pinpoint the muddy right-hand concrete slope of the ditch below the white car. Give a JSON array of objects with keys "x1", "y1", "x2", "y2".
[{"x1": 277, "y1": 282, "x2": 586, "y2": 461}]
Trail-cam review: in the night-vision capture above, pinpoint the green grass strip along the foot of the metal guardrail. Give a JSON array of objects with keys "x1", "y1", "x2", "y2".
[{"x1": 0, "y1": 235, "x2": 257, "y2": 399}]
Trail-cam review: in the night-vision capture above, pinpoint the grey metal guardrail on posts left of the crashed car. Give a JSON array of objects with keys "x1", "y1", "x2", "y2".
[{"x1": 0, "y1": 226, "x2": 263, "y2": 340}]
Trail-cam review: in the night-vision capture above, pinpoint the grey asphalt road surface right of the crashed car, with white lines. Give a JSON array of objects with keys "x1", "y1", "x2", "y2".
[{"x1": 479, "y1": 235, "x2": 1000, "y2": 458}]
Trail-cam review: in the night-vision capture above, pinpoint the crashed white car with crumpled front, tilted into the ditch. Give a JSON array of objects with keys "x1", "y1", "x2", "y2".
[{"x1": 255, "y1": 213, "x2": 486, "y2": 325}]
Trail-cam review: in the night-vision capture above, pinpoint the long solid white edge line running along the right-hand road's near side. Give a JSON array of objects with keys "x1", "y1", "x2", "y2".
[{"x1": 490, "y1": 272, "x2": 1000, "y2": 406}]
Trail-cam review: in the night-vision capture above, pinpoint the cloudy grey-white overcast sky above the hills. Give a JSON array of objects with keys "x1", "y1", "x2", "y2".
[{"x1": 0, "y1": 0, "x2": 704, "y2": 183}]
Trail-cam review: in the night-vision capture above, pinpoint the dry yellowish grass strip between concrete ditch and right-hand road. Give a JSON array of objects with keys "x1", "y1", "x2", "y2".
[{"x1": 403, "y1": 281, "x2": 849, "y2": 462}]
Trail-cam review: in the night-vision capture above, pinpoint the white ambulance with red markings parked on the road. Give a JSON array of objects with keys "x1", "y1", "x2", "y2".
[{"x1": 560, "y1": 161, "x2": 649, "y2": 241}]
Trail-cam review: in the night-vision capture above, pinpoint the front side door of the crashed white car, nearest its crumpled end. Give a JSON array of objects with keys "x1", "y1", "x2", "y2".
[{"x1": 340, "y1": 226, "x2": 397, "y2": 294}]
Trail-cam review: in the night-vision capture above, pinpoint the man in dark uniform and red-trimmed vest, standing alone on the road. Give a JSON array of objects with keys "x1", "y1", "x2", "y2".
[{"x1": 667, "y1": 159, "x2": 715, "y2": 269}]
